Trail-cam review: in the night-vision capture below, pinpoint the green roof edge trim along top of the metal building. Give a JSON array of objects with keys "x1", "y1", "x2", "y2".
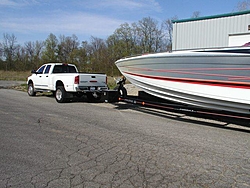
[{"x1": 172, "y1": 10, "x2": 250, "y2": 23}]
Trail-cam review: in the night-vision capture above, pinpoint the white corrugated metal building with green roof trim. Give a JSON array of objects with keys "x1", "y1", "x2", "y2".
[{"x1": 172, "y1": 10, "x2": 250, "y2": 50}]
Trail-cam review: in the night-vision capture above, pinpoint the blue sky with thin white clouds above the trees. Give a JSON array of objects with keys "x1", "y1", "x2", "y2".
[{"x1": 0, "y1": 0, "x2": 246, "y2": 45}]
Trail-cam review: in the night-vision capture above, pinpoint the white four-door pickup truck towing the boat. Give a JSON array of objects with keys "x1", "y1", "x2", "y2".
[{"x1": 27, "y1": 63, "x2": 108, "y2": 103}]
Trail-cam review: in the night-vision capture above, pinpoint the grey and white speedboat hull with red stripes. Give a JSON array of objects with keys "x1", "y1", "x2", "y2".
[{"x1": 115, "y1": 46, "x2": 250, "y2": 114}]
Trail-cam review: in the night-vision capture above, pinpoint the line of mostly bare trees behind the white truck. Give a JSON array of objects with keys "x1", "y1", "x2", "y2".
[{"x1": 0, "y1": 17, "x2": 172, "y2": 75}]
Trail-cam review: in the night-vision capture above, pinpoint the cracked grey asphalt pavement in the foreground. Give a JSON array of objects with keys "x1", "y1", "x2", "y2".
[{"x1": 0, "y1": 89, "x2": 250, "y2": 188}]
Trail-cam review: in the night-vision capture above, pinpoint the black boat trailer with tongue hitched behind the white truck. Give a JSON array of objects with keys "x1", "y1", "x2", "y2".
[{"x1": 103, "y1": 77, "x2": 250, "y2": 127}]
